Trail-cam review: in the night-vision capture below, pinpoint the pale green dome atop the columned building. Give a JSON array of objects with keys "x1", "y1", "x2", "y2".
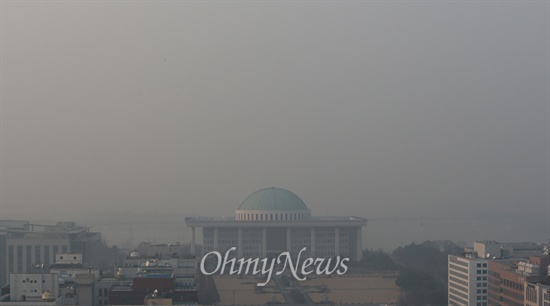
[{"x1": 238, "y1": 187, "x2": 308, "y2": 210}]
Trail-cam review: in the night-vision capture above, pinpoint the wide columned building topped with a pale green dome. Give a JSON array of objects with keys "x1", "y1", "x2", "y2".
[{"x1": 185, "y1": 187, "x2": 367, "y2": 260}]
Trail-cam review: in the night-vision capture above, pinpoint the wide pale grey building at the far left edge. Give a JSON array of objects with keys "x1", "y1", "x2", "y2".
[{"x1": 0, "y1": 220, "x2": 101, "y2": 286}]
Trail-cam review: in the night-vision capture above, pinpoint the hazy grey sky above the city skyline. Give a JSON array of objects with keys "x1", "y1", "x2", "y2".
[{"x1": 0, "y1": 1, "x2": 550, "y2": 246}]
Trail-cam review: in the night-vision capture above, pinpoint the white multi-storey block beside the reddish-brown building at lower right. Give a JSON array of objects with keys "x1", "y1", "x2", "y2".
[{"x1": 448, "y1": 254, "x2": 489, "y2": 306}]
